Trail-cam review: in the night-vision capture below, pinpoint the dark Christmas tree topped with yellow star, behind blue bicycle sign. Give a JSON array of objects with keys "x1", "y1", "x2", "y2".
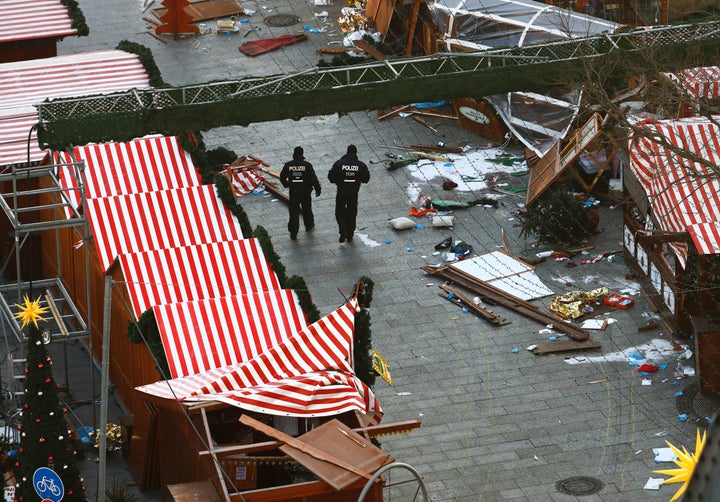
[{"x1": 14, "y1": 296, "x2": 87, "y2": 502}]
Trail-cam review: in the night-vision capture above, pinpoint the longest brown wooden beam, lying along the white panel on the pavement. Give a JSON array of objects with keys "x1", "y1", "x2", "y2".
[{"x1": 422, "y1": 266, "x2": 590, "y2": 341}]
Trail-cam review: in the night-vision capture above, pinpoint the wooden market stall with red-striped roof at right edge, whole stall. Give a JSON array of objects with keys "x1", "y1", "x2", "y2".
[{"x1": 624, "y1": 117, "x2": 720, "y2": 392}]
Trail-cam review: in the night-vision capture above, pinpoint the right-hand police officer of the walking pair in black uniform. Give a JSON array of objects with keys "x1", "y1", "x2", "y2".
[{"x1": 328, "y1": 145, "x2": 370, "y2": 242}]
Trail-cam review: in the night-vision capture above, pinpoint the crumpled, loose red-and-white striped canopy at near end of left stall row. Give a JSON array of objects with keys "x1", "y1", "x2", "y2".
[{"x1": 137, "y1": 300, "x2": 382, "y2": 425}]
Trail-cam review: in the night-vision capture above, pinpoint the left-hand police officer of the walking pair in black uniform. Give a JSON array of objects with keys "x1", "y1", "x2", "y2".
[{"x1": 280, "y1": 146, "x2": 320, "y2": 240}]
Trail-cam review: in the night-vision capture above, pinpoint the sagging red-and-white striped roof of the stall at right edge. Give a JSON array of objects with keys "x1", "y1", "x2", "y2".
[{"x1": 630, "y1": 118, "x2": 720, "y2": 268}]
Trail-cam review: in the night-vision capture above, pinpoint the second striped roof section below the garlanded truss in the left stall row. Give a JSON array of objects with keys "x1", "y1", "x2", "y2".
[{"x1": 86, "y1": 185, "x2": 243, "y2": 270}]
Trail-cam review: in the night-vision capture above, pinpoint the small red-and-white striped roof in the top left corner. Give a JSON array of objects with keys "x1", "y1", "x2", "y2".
[{"x1": 0, "y1": 0, "x2": 78, "y2": 43}]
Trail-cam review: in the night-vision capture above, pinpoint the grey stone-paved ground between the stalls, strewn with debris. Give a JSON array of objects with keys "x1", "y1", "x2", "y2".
[{"x1": 50, "y1": 0, "x2": 708, "y2": 502}]
